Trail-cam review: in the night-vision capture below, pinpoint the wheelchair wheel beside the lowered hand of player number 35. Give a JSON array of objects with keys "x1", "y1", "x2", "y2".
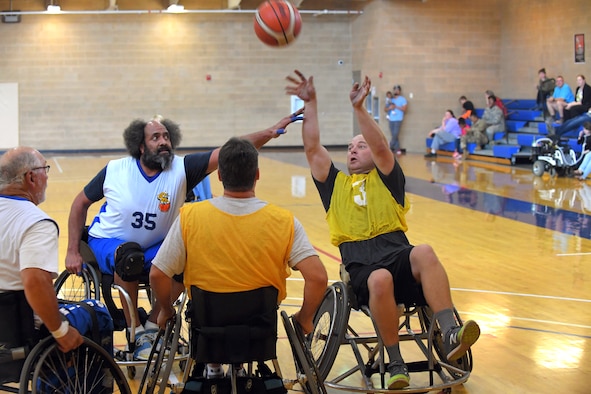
[{"x1": 53, "y1": 264, "x2": 101, "y2": 301}]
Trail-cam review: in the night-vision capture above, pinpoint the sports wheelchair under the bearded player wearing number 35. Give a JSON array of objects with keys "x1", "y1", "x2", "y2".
[{"x1": 54, "y1": 228, "x2": 188, "y2": 379}]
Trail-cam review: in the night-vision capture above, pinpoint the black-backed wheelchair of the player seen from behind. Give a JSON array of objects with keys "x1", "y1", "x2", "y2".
[{"x1": 140, "y1": 286, "x2": 326, "y2": 394}]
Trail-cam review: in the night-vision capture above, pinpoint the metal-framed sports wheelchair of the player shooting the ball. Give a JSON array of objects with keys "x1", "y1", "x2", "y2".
[{"x1": 307, "y1": 266, "x2": 472, "y2": 393}]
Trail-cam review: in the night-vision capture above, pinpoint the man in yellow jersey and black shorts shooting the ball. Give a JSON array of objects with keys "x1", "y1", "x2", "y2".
[{"x1": 286, "y1": 70, "x2": 480, "y2": 389}]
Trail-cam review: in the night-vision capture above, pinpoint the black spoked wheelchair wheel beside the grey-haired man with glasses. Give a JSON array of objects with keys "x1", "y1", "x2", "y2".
[{"x1": 19, "y1": 337, "x2": 131, "y2": 394}]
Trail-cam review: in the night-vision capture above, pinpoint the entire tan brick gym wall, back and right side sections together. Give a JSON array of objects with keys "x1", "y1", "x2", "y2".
[{"x1": 0, "y1": 0, "x2": 591, "y2": 152}]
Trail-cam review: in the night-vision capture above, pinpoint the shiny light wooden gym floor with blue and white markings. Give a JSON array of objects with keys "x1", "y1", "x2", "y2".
[{"x1": 41, "y1": 150, "x2": 591, "y2": 394}]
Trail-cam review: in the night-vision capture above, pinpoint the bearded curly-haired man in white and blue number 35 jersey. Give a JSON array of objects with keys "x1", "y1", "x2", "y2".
[{"x1": 66, "y1": 112, "x2": 300, "y2": 359}]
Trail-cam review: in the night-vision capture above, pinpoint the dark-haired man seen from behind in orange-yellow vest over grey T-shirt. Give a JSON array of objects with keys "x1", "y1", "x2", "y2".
[{"x1": 150, "y1": 138, "x2": 328, "y2": 377}]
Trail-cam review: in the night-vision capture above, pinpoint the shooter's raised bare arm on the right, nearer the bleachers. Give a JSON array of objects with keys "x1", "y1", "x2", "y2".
[{"x1": 349, "y1": 76, "x2": 394, "y2": 175}]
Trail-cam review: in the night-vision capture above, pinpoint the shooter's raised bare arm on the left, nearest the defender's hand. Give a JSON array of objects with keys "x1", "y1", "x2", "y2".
[{"x1": 285, "y1": 70, "x2": 332, "y2": 182}]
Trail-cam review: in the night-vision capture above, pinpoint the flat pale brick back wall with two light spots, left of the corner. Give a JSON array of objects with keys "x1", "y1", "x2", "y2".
[{"x1": 0, "y1": 14, "x2": 352, "y2": 150}]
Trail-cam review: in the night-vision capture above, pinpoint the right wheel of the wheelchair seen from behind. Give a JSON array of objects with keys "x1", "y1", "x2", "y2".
[{"x1": 281, "y1": 311, "x2": 326, "y2": 394}]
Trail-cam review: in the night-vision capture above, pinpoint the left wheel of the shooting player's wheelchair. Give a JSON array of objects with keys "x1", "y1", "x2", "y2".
[{"x1": 307, "y1": 282, "x2": 351, "y2": 381}]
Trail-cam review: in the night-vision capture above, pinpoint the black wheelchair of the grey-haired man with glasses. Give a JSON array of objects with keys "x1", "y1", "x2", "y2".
[{"x1": 0, "y1": 291, "x2": 131, "y2": 394}]
